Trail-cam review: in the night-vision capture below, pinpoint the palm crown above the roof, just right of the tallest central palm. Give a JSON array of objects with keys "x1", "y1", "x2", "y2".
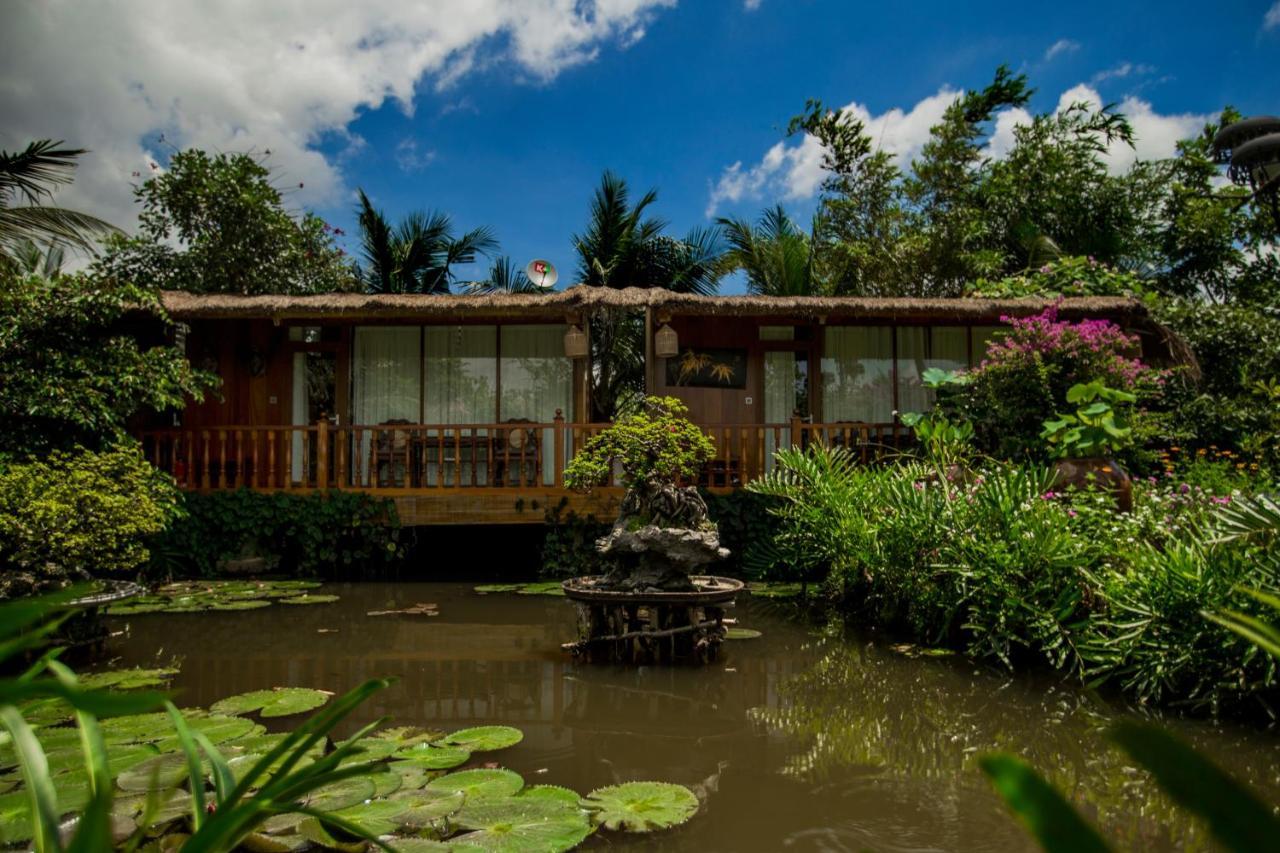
[{"x1": 718, "y1": 205, "x2": 822, "y2": 296}]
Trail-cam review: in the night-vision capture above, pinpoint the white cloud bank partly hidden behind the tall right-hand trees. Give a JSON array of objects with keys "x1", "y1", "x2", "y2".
[{"x1": 705, "y1": 83, "x2": 1213, "y2": 218}]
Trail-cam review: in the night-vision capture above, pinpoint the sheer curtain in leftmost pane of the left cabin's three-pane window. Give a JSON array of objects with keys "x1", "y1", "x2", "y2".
[{"x1": 351, "y1": 325, "x2": 422, "y2": 482}]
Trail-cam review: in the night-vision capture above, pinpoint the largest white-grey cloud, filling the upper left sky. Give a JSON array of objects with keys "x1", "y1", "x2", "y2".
[{"x1": 0, "y1": 0, "x2": 676, "y2": 225}]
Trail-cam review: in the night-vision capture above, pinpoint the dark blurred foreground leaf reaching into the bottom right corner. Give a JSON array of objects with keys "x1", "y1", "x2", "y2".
[{"x1": 1110, "y1": 722, "x2": 1280, "y2": 853}]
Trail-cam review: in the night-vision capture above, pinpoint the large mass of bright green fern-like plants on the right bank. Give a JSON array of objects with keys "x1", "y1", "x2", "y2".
[{"x1": 749, "y1": 447, "x2": 1276, "y2": 710}]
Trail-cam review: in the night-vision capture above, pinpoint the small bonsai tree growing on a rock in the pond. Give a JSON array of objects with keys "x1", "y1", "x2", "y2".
[{"x1": 564, "y1": 397, "x2": 728, "y2": 590}]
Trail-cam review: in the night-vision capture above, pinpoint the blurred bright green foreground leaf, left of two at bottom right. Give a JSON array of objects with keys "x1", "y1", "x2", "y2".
[{"x1": 978, "y1": 753, "x2": 1111, "y2": 853}]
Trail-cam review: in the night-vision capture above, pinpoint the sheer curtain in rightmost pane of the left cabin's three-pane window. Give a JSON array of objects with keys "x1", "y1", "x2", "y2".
[{"x1": 500, "y1": 325, "x2": 573, "y2": 484}]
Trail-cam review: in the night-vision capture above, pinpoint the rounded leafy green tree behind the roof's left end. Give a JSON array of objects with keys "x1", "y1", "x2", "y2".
[{"x1": 97, "y1": 149, "x2": 356, "y2": 293}]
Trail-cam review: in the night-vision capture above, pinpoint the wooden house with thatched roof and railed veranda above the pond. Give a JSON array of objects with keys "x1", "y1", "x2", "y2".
[{"x1": 141, "y1": 287, "x2": 1169, "y2": 524}]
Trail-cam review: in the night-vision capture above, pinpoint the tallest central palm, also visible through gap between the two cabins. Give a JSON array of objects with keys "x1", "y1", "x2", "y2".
[{"x1": 573, "y1": 172, "x2": 722, "y2": 420}]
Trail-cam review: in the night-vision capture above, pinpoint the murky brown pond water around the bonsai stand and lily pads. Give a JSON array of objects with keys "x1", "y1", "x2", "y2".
[{"x1": 104, "y1": 583, "x2": 1280, "y2": 853}]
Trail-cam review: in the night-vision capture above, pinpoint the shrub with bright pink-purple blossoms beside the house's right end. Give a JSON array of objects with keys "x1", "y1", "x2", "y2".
[{"x1": 938, "y1": 306, "x2": 1164, "y2": 460}]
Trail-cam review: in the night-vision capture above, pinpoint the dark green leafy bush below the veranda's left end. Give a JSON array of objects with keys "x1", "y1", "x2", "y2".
[{"x1": 147, "y1": 489, "x2": 404, "y2": 578}]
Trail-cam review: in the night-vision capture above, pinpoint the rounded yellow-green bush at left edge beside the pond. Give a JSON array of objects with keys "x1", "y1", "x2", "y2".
[{"x1": 0, "y1": 446, "x2": 178, "y2": 598}]
